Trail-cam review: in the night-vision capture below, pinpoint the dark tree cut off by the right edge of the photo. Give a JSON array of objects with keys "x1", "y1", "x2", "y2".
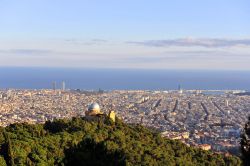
[{"x1": 240, "y1": 117, "x2": 250, "y2": 165}]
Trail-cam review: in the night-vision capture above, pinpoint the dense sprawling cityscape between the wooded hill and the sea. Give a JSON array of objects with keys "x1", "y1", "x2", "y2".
[{"x1": 0, "y1": 87, "x2": 250, "y2": 154}]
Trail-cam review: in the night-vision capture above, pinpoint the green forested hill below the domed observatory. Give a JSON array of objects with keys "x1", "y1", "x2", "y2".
[{"x1": 0, "y1": 117, "x2": 241, "y2": 166}]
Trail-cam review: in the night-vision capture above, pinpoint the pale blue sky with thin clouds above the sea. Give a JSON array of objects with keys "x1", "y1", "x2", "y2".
[{"x1": 0, "y1": 0, "x2": 250, "y2": 70}]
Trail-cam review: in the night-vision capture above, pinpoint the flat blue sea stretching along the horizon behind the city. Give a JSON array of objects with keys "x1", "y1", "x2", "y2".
[{"x1": 0, "y1": 67, "x2": 250, "y2": 91}]
